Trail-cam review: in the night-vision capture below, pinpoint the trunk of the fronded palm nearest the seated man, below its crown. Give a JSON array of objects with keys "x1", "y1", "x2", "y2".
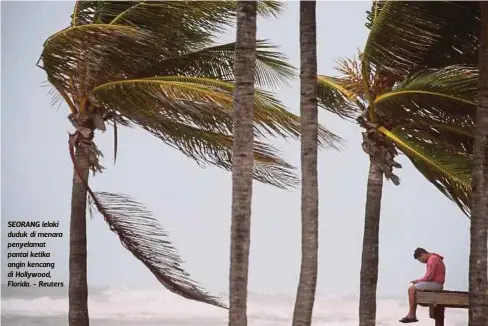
[{"x1": 359, "y1": 158, "x2": 383, "y2": 326}]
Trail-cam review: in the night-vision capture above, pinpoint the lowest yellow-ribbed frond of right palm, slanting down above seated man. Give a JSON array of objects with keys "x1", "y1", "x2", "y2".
[{"x1": 378, "y1": 127, "x2": 472, "y2": 216}]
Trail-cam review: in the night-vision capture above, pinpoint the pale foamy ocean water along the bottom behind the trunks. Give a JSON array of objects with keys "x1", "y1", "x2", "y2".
[{"x1": 1, "y1": 287, "x2": 468, "y2": 326}]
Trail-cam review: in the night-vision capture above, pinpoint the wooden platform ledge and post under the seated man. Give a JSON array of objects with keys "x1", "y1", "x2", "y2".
[{"x1": 415, "y1": 291, "x2": 469, "y2": 326}]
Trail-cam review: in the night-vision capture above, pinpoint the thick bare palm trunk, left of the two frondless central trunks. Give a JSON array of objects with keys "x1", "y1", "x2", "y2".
[{"x1": 229, "y1": 1, "x2": 257, "y2": 326}]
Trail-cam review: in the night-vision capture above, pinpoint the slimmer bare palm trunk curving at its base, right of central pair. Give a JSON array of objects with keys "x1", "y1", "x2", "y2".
[{"x1": 293, "y1": 1, "x2": 319, "y2": 326}]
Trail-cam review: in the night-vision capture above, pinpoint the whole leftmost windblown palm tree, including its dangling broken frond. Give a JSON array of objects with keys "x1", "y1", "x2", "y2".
[{"x1": 38, "y1": 1, "x2": 344, "y2": 326}]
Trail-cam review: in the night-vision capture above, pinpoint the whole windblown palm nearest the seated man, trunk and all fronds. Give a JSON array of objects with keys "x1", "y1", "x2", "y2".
[{"x1": 318, "y1": 1, "x2": 479, "y2": 326}]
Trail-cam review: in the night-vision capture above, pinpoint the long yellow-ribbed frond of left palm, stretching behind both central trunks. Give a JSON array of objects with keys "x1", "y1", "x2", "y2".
[{"x1": 90, "y1": 76, "x2": 341, "y2": 147}]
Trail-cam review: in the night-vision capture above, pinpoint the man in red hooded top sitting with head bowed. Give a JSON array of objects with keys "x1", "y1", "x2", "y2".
[{"x1": 400, "y1": 248, "x2": 446, "y2": 323}]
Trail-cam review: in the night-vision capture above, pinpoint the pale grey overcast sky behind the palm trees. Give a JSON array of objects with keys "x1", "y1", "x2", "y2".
[{"x1": 1, "y1": 1, "x2": 469, "y2": 295}]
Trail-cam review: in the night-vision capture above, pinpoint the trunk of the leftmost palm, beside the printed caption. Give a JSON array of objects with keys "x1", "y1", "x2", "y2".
[{"x1": 68, "y1": 146, "x2": 90, "y2": 326}]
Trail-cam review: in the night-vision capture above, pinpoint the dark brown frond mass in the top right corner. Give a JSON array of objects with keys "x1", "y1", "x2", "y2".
[{"x1": 364, "y1": 1, "x2": 480, "y2": 79}]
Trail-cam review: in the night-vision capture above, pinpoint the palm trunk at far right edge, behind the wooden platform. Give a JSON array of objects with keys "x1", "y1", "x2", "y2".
[{"x1": 469, "y1": 1, "x2": 488, "y2": 326}]
